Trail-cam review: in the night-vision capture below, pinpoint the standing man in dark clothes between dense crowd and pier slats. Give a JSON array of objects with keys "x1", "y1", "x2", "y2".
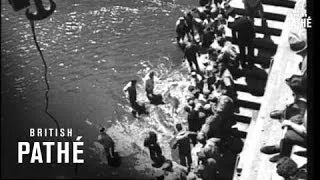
[{"x1": 229, "y1": 16, "x2": 255, "y2": 68}]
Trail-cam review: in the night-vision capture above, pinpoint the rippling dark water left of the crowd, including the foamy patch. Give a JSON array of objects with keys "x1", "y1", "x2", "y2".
[{"x1": 1, "y1": 0, "x2": 197, "y2": 178}]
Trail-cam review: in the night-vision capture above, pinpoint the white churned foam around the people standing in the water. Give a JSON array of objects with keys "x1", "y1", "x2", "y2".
[{"x1": 87, "y1": 57, "x2": 194, "y2": 174}]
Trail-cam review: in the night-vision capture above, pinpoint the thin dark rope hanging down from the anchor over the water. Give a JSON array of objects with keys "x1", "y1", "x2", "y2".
[{"x1": 30, "y1": 20, "x2": 78, "y2": 177}]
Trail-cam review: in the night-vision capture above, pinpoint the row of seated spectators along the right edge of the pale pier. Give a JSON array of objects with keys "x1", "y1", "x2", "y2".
[{"x1": 261, "y1": 29, "x2": 307, "y2": 180}]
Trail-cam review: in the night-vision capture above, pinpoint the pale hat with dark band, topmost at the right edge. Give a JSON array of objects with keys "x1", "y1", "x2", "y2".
[{"x1": 289, "y1": 31, "x2": 308, "y2": 53}]
